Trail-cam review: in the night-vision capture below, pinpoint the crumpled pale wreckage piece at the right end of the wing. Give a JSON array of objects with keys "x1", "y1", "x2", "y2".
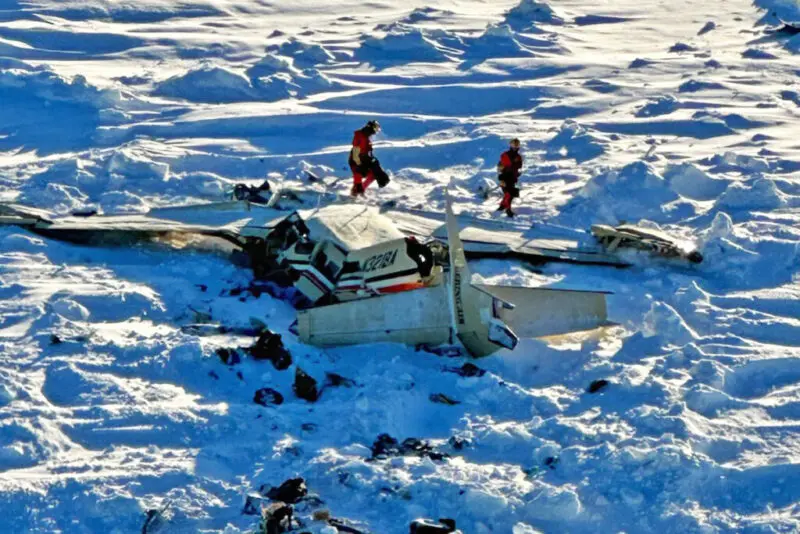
[{"x1": 592, "y1": 224, "x2": 703, "y2": 263}]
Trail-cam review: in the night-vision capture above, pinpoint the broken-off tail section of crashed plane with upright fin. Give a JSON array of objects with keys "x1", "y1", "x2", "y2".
[{"x1": 297, "y1": 202, "x2": 607, "y2": 357}]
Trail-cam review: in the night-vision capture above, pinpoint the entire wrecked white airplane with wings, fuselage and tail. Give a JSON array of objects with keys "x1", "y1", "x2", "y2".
[{"x1": 0, "y1": 195, "x2": 612, "y2": 357}]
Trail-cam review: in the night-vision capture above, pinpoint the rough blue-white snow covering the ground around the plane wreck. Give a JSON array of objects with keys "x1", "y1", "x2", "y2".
[{"x1": 0, "y1": 0, "x2": 800, "y2": 534}]
